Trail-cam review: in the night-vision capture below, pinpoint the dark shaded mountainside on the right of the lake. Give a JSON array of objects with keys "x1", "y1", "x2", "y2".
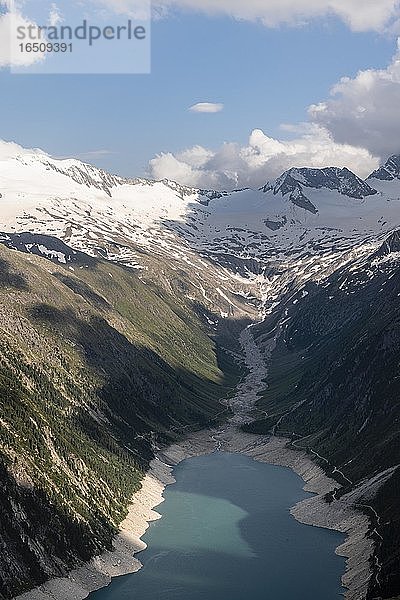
[{"x1": 246, "y1": 231, "x2": 400, "y2": 599}]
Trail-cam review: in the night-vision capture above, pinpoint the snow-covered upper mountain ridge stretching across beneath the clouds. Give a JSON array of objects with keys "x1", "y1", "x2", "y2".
[{"x1": 0, "y1": 146, "x2": 400, "y2": 310}]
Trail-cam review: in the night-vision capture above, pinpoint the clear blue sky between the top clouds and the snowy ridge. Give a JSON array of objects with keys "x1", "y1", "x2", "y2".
[{"x1": 0, "y1": 2, "x2": 396, "y2": 186}]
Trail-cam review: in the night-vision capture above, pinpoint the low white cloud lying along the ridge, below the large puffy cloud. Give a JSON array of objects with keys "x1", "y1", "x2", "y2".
[{"x1": 149, "y1": 124, "x2": 379, "y2": 190}]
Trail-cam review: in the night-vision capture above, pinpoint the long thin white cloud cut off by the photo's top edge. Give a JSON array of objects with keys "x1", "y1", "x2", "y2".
[{"x1": 90, "y1": 0, "x2": 400, "y2": 31}]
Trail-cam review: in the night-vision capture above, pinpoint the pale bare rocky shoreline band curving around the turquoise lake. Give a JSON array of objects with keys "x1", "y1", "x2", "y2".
[{"x1": 17, "y1": 425, "x2": 374, "y2": 600}]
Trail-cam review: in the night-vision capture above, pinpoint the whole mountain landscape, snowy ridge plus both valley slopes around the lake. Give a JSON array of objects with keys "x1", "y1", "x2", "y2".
[{"x1": 0, "y1": 146, "x2": 400, "y2": 599}]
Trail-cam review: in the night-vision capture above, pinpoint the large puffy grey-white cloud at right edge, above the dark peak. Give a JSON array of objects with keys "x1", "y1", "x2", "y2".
[{"x1": 309, "y1": 39, "x2": 400, "y2": 158}]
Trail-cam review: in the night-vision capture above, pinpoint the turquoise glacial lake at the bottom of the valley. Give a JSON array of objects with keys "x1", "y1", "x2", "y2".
[{"x1": 89, "y1": 452, "x2": 345, "y2": 600}]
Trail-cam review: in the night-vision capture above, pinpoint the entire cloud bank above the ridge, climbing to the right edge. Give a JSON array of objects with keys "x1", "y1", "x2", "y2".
[{"x1": 150, "y1": 42, "x2": 400, "y2": 189}]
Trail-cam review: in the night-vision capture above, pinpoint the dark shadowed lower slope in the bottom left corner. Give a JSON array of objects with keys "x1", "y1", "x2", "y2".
[{"x1": 0, "y1": 462, "x2": 108, "y2": 600}]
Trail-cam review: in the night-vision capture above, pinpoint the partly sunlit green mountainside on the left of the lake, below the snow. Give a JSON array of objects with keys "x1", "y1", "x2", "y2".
[{"x1": 0, "y1": 247, "x2": 238, "y2": 598}]
